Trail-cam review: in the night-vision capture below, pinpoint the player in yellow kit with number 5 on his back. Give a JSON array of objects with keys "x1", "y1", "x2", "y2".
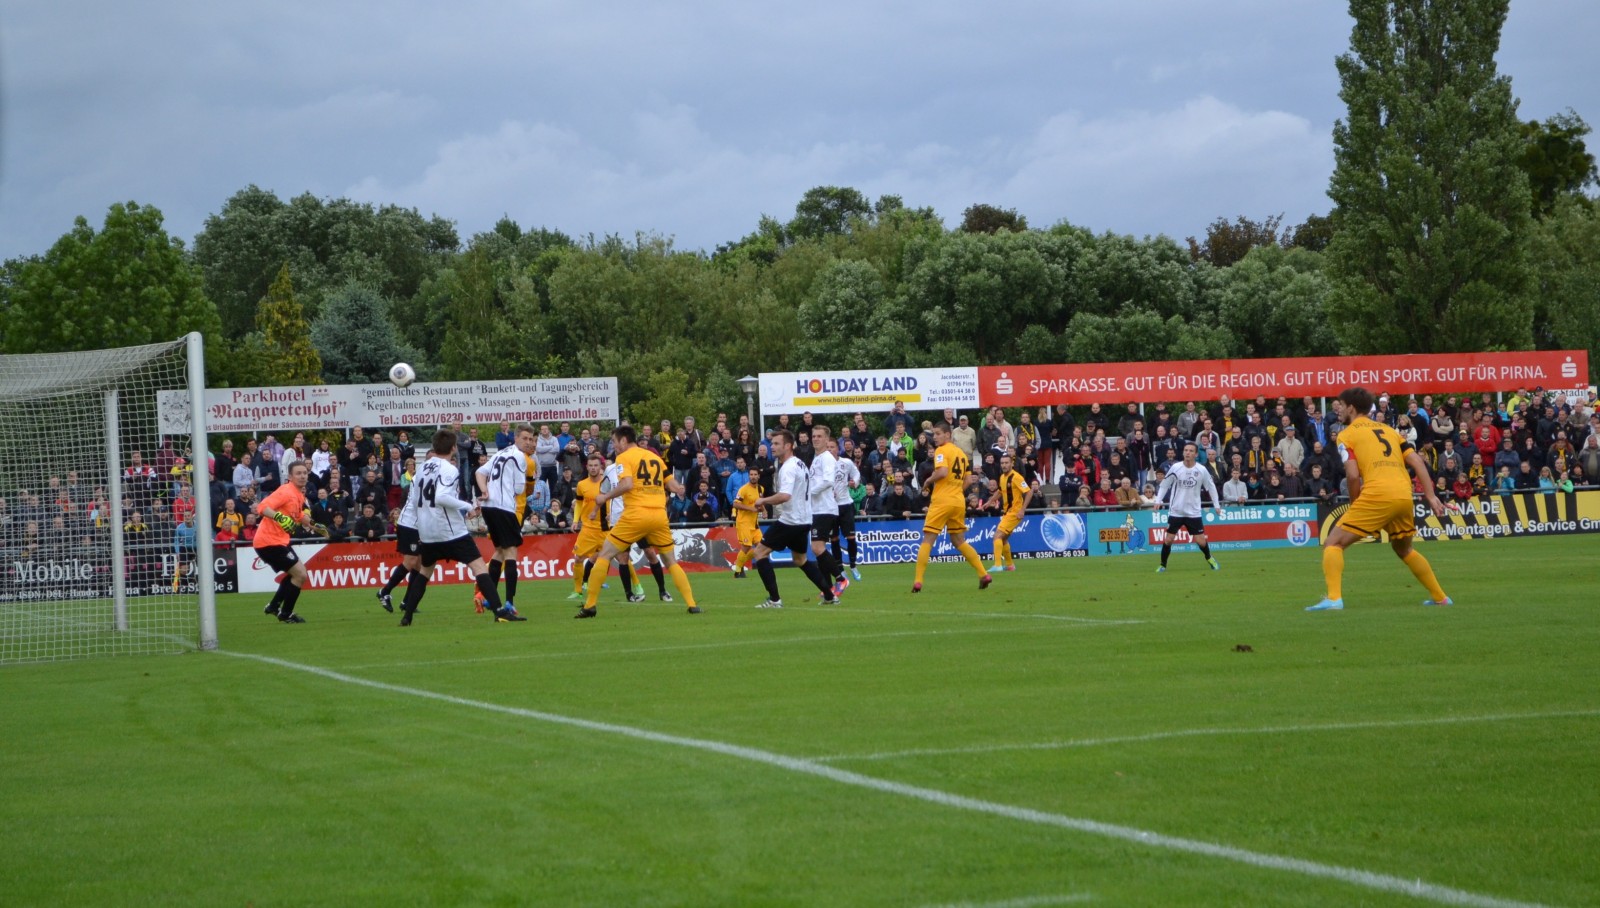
[{"x1": 1306, "y1": 388, "x2": 1451, "y2": 612}]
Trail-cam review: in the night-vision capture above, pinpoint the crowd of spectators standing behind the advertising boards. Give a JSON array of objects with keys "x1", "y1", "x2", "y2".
[{"x1": 0, "y1": 388, "x2": 1600, "y2": 569}]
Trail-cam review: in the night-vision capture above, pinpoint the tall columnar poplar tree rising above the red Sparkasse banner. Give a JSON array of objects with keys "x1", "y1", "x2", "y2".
[{"x1": 1328, "y1": 0, "x2": 1533, "y2": 353}]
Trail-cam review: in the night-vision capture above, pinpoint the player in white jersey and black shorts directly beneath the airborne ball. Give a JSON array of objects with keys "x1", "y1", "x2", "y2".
[{"x1": 400, "y1": 428, "x2": 526, "y2": 627}]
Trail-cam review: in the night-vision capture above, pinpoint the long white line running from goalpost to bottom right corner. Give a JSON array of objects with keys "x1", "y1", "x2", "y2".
[{"x1": 216, "y1": 649, "x2": 1544, "y2": 908}]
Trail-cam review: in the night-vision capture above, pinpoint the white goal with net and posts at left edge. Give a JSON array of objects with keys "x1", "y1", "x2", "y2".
[{"x1": 0, "y1": 334, "x2": 216, "y2": 663}]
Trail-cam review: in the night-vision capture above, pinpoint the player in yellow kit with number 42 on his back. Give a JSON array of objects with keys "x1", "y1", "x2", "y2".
[{"x1": 573, "y1": 425, "x2": 701, "y2": 619}]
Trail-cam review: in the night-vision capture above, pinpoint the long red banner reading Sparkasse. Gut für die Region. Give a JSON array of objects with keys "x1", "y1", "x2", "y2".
[{"x1": 978, "y1": 350, "x2": 1589, "y2": 406}]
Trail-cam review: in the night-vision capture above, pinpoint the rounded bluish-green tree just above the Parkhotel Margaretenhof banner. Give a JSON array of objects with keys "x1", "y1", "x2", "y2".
[{"x1": 310, "y1": 281, "x2": 426, "y2": 385}]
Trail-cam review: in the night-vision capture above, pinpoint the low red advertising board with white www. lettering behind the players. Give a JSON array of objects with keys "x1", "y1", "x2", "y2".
[{"x1": 238, "y1": 526, "x2": 739, "y2": 593}]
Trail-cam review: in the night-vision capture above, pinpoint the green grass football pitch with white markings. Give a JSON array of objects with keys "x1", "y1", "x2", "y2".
[{"x1": 0, "y1": 537, "x2": 1600, "y2": 906}]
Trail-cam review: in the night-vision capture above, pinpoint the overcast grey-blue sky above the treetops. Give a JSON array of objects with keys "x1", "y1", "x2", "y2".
[{"x1": 0, "y1": 0, "x2": 1600, "y2": 257}]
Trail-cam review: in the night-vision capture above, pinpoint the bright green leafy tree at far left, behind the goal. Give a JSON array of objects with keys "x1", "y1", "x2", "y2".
[{"x1": 0, "y1": 201, "x2": 221, "y2": 356}]
